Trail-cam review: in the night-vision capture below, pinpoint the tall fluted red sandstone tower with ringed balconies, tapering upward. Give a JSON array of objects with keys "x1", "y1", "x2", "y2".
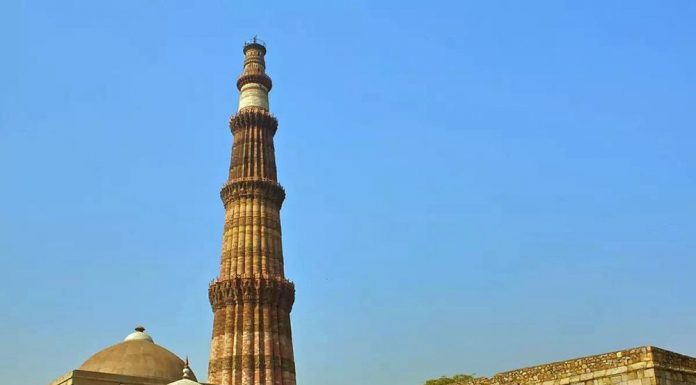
[{"x1": 208, "y1": 38, "x2": 295, "y2": 385}]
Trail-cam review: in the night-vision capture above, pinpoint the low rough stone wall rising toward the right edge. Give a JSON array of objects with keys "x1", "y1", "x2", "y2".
[{"x1": 456, "y1": 346, "x2": 696, "y2": 385}]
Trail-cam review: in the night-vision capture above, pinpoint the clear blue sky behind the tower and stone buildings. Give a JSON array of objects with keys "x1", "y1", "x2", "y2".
[{"x1": 0, "y1": 0, "x2": 696, "y2": 385}]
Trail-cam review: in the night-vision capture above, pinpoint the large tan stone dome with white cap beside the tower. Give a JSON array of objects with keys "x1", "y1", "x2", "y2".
[{"x1": 79, "y1": 327, "x2": 196, "y2": 382}]
